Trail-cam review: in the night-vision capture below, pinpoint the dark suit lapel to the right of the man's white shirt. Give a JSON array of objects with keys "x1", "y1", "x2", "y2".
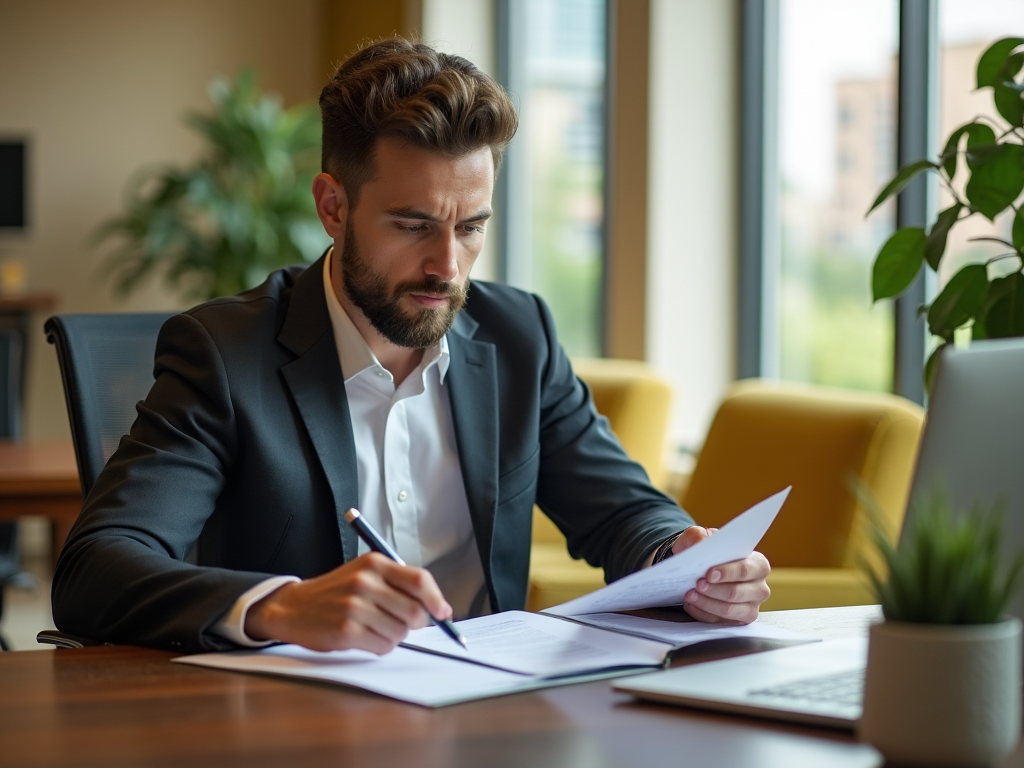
[{"x1": 445, "y1": 312, "x2": 498, "y2": 606}]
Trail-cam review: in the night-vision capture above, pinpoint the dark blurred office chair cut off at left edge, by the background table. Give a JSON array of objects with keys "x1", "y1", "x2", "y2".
[{"x1": 0, "y1": 331, "x2": 35, "y2": 650}]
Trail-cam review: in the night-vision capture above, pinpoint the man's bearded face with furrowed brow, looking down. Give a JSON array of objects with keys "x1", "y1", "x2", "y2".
[{"x1": 341, "y1": 139, "x2": 494, "y2": 349}]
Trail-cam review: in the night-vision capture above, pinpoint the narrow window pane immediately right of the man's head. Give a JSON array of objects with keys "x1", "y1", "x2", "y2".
[{"x1": 510, "y1": 0, "x2": 605, "y2": 355}]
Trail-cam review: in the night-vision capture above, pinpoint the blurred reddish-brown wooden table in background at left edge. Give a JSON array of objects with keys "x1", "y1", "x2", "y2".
[{"x1": 0, "y1": 440, "x2": 82, "y2": 561}]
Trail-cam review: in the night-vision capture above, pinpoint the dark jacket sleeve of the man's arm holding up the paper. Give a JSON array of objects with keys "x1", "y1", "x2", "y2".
[{"x1": 536, "y1": 298, "x2": 693, "y2": 583}]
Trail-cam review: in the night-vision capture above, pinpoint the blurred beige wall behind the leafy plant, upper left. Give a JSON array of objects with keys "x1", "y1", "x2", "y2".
[{"x1": 0, "y1": 0, "x2": 326, "y2": 438}]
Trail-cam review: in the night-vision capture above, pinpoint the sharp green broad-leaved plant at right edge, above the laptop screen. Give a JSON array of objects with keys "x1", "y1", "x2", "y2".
[{"x1": 868, "y1": 38, "x2": 1024, "y2": 383}]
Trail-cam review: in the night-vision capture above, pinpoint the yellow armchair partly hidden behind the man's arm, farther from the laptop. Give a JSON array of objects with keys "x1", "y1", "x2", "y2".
[{"x1": 526, "y1": 359, "x2": 672, "y2": 610}]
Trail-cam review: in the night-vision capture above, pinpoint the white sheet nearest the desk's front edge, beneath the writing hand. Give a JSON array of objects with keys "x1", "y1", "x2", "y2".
[{"x1": 174, "y1": 641, "x2": 538, "y2": 707}]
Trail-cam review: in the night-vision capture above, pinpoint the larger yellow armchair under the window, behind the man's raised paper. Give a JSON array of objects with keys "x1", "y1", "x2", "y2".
[{"x1": 682, "y1": 381, "x2": 924, "y2": 610}]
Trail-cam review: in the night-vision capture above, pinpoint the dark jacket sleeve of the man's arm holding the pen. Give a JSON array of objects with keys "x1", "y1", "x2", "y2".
[{"x1": 52, "y1": 314, "x2": 269, "y2": 651}]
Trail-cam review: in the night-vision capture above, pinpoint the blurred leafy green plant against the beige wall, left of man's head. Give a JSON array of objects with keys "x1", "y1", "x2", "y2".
[{"x1": 95, "y1": 71, "x2": 327, "y2": 301}]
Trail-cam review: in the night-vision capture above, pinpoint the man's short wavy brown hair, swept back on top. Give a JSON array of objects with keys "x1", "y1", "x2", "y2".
[{"x1": 319, "y1": 37, "x2": 519, "y2": 206}]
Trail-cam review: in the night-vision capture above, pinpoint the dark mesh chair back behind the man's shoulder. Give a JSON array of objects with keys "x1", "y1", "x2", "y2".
[{"x1": 46, "y1": 312, "x2": 171, "y2": 494}]
